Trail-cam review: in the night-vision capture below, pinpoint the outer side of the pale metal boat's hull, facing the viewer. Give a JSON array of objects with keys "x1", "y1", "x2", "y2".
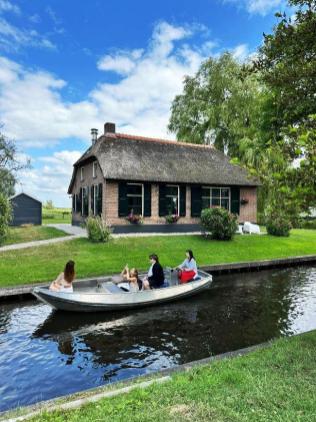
[{"x1": 33, "y1": 273, "x2": 212, "y2": 312}]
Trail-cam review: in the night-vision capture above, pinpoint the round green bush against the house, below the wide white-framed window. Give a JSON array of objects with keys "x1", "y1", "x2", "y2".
[{"x1": 201, "y1": 208, "x2": 238, "y2": 240}]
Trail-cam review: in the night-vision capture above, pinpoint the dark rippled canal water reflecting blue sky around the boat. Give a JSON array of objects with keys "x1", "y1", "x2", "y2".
[{"x1": 0, "y1": 267, "x2": 316, "y2": 410}]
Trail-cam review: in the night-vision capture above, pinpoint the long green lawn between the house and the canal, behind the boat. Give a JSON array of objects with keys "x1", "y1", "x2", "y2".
[{"x1": 0, "y1": 230, "x2": 316, "y2": 287}]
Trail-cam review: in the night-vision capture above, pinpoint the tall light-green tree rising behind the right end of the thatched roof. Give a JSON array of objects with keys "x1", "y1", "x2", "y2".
[{"x1": 168, "y1": 53, "x2": 268, "y2": 157}]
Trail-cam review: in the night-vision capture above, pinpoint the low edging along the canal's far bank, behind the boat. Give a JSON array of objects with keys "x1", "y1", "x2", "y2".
[{"x1": 0, "y1": 255, "x2": 316, "y2": 301}]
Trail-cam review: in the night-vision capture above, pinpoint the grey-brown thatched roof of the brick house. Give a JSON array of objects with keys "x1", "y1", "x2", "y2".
[{"x1": 69, "y1": 133, "x2": 259, "y2": 193}]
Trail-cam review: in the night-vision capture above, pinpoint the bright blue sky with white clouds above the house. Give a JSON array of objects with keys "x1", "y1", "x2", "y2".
[{"x1": 0, "y1": 0, "x2": 292, "y2": 207}]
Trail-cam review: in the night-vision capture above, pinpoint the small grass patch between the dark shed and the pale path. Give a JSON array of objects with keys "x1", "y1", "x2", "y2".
[{"x1": 1, "y1": 226, "x2": 67, "y2": 246}]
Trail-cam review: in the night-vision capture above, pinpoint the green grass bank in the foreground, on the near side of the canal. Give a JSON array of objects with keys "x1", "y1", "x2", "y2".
[{"x1": 26, "y1": 331, "x2": 316, "y2": 422}]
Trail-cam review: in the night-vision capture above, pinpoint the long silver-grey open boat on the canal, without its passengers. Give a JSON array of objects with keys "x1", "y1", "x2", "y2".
[{"x1": 32, "y1": 269, "x2": 213, "y2": 312}]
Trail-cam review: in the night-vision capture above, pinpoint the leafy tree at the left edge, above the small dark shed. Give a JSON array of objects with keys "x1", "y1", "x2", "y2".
[{"x1": 0, "y1": 129, "x2": 30, "y2": 197}]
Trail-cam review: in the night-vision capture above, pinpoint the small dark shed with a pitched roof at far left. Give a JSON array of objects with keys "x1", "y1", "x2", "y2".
[{"x1": 10, "y1": 193, "x2": 42, "y2": 226}]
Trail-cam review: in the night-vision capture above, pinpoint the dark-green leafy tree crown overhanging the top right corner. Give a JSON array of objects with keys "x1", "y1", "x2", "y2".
[{"x1": 254, "y1": 0, "x2": 316, "y2": 128}]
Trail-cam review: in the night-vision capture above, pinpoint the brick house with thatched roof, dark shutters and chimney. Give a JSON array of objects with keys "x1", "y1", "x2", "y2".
[{"x1": 68, "y1": 123, "x2": 259, "y2": 232}]
